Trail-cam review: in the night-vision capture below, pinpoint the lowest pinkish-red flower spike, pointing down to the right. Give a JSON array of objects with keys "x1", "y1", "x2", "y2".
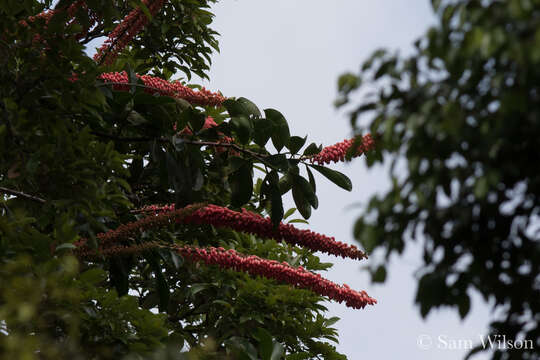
[{"x1": 176, "y1": 246, "x2": 377, "y2": 309}]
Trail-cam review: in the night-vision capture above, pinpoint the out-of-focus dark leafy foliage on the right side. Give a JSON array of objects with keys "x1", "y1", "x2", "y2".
[{"x1": 337, "y1": 0, "x2": 540, "y2": 359}]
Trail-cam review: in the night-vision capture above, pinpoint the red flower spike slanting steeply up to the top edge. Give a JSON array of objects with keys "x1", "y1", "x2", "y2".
[{"x1": 94, "y1": 0, "x2": 165, "y2": 65}]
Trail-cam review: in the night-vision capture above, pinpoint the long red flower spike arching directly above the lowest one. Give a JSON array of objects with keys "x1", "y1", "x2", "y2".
[{"x1": 142, "y1": 205, "x2": 367, "y2": 259}]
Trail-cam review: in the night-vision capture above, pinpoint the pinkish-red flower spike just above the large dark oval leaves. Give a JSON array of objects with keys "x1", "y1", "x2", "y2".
[{"x1": 98, "y1": 71, "x2": 226, "y2": 107}]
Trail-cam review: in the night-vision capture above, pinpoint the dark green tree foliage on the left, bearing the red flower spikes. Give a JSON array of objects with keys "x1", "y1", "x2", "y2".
[{"x1": 0, "y1": 0, "x2": 362, "y2": 360}]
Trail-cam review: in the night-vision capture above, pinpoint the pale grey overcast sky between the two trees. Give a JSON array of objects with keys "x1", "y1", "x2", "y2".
[{"x1": 193, "y1": 0, "x2": 490, "y2": 360}]
